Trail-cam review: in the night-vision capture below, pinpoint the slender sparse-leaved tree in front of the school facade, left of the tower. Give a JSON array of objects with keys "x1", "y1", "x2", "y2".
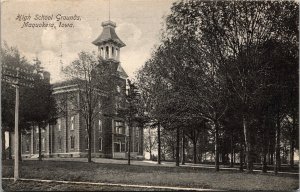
[{"x1": 64, "y1": 52, "x2": 109, "y2": 163}]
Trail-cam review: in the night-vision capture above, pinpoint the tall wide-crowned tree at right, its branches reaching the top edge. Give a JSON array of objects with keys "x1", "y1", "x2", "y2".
[{"x1": 167, "y1": 1, "x2": 298, "y2": 171}]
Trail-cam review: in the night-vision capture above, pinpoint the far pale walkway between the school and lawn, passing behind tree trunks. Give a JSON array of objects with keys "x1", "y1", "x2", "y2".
[{"x1": 24, "y1": 158, "x2": 299, "y2": 175}]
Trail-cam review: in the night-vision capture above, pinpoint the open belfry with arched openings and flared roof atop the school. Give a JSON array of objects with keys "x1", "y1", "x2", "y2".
[{"x1": 93, "y1": 20, "x2": 125, "y2": 62}]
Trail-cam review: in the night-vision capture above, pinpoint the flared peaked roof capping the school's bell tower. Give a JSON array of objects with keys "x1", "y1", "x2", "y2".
[{"x1": 93, "y1": 21, "x2": 125, "y2": 47}]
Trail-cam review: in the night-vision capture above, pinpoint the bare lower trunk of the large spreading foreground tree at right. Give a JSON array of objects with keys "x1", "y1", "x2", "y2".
[{"x1": 243, "y1": 116, "x2": 253, "y2": 172}]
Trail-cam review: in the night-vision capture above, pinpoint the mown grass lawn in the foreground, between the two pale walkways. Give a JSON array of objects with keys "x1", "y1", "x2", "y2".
[{"x1": 2, "y1": 160, "x2": 299, "y2": 191}]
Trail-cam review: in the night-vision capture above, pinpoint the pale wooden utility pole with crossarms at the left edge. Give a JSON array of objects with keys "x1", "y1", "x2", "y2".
[{"x1": 2, "y1": 65, "x2": 33, "y2": 181}]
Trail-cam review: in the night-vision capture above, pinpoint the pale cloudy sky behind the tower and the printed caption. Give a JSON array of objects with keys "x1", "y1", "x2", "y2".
[{"x1": 1, "y1": 0, "x2": 175, "y2": 83}]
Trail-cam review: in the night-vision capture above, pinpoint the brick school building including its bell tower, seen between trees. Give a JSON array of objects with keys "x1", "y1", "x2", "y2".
[{"x1": 21, "y1": 18, "x2": 143, "y2": 158}]
